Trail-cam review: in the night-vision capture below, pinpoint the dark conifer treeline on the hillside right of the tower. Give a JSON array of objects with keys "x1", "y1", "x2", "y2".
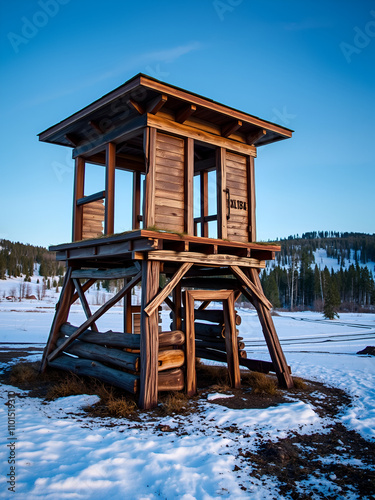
[{"x1": 261, "y1": 231, "x2": 375, "y2": 311}]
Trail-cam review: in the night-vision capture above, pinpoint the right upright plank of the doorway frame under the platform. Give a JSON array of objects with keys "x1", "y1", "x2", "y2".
[{"x1": 223, "y1": 292, "x2": 241, "y2": 389}]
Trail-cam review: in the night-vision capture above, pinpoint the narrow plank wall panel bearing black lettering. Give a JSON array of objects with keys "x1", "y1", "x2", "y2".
[{"x1": 225, "y1": 151, "x2": 250, "y2": 243}]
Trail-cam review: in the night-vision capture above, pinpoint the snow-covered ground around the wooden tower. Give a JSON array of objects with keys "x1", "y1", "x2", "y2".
[{"x1": 0, "y1": 282, "x2": 375, "y2": 500}]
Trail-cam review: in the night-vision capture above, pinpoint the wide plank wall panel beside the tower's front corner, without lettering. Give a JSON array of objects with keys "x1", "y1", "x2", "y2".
[{"x1": 155, "y1": 132, "x2": 185, "y2": 233}]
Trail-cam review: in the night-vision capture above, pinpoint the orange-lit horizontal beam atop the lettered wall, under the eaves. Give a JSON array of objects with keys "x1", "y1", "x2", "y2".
[{"x1": 147, "y1": 114, "x2": 257, "y2": 156}]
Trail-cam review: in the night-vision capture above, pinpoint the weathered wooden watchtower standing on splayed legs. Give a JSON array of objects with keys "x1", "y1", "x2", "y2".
[{"x1": 39, "y1": 74, "x2": 293, "y2": 408}]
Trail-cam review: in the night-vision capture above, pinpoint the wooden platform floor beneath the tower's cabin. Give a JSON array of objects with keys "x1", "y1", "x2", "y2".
[{"x1": 50, "y1": 229, "x2": 280, "y2": 269}]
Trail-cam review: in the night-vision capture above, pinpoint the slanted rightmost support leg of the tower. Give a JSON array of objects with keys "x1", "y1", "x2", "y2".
[{"x1": 245, "y1": 268, "x2": 294, "y2": 389}]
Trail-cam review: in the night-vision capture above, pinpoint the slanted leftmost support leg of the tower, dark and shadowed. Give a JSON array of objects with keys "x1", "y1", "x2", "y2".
[{"x1": 40, "y1": 267, "x2": 74, "y2": 373}]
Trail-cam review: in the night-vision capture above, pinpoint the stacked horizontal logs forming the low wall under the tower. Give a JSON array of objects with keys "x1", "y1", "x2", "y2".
[{"x1": 49, "y1": 323, "x2": 185, "y2": 394}]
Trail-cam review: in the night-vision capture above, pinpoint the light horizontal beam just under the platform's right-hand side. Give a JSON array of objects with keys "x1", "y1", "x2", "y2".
[{"x1": 145, "y1": 250, "x2": 266, "y2": 269}]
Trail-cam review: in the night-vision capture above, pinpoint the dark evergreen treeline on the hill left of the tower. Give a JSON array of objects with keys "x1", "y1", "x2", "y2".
[{"x1": 0, "y1": 240, "x2": 64, "y2": 279}]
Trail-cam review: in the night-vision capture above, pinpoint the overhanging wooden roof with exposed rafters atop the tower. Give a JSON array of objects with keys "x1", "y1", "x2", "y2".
[{"x1": 39, "y1": 73, "x2": 293, "y2": 147}]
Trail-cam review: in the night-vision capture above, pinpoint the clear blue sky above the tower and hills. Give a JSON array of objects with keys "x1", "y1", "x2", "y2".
[{"x1": 0, "y1": 0, "x2": 375, "y2": 246}]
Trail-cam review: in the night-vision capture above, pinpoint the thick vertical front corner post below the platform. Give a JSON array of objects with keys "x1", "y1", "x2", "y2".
[{"x1": 139, "y1": 260, "x2": 160, "y2": 410}]
